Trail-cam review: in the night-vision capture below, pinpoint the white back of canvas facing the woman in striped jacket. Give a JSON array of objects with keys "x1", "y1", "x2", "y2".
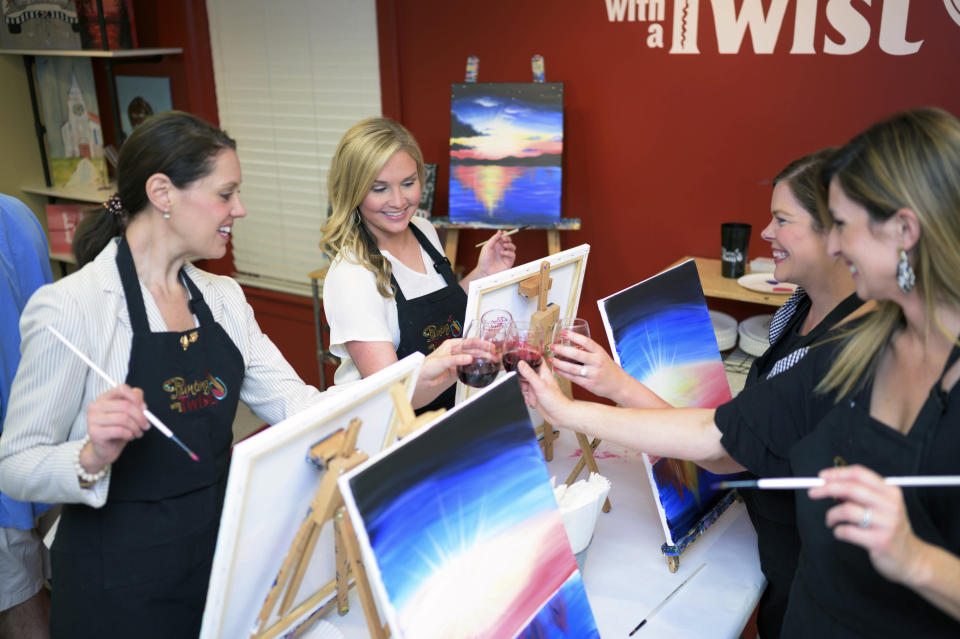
[{"x1": 200, "y1": 353, "x2": 424, "y2": 639}]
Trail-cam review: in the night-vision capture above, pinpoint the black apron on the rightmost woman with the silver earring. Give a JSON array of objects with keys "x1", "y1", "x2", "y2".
[{"x1": 781, "y1": 346, "x2": 960, "y2": 639}]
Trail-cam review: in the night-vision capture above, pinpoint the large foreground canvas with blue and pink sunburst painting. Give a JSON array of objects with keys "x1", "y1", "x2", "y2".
[{"x1": 339, "y1": 375, "x2": 599, "y2": 639}]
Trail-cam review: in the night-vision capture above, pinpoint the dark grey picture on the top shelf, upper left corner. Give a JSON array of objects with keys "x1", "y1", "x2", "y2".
[{"x1": 0, "y1": 0, "x2": 80, "y2": 49}]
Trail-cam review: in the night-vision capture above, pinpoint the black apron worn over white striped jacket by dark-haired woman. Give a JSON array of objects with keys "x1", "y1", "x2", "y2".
[{"x1": 51, "y1": 238, "x2": 244, "y2": 639}]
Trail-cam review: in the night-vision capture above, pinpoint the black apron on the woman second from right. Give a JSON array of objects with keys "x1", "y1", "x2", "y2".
[{"x1": 740, "y1": 293, "x2": 863, "y2": 639}]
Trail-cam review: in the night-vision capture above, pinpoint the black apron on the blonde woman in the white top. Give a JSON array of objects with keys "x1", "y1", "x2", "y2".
[{"x1": 390, "y1": 224, "x2": 467, "y2": 415}]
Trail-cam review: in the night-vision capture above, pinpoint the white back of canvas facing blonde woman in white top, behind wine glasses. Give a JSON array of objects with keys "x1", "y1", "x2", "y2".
[{"x1": 457, "y1": 244, "x2": 590, "y2": 402}]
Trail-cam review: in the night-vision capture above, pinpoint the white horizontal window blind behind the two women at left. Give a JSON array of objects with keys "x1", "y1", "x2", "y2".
[{"x1": 207, "y1": 0, "x2": 381, "y2": 295}]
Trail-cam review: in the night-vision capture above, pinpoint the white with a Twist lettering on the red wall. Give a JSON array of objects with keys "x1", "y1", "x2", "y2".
[{"x1": 596, "y1": 0, "x2": 940, "y2": 55}]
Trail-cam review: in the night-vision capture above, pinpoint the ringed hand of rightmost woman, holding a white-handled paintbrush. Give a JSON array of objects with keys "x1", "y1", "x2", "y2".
[{"x1": 808, "y1": 465, "x2": 924, "y2": 583}]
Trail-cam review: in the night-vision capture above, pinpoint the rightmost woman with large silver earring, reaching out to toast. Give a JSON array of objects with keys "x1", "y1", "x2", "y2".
[{"x1": 521, "y1": 109, "x2": 960, "y2": 639}]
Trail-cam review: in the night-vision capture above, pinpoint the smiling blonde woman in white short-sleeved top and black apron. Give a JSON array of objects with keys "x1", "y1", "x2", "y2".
[{"x1": 321, "y1": 118, "x2": 516, "y2": 411}]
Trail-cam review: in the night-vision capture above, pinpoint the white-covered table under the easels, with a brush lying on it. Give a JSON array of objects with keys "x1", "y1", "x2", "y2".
[{"x1": 303, "y1": 431, "x2": 765, "y2": 639}]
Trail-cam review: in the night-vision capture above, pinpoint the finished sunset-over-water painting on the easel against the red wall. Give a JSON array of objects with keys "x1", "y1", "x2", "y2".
[{"x1": 449, "y1": 82, "x2": 563, "y2": 224}]
